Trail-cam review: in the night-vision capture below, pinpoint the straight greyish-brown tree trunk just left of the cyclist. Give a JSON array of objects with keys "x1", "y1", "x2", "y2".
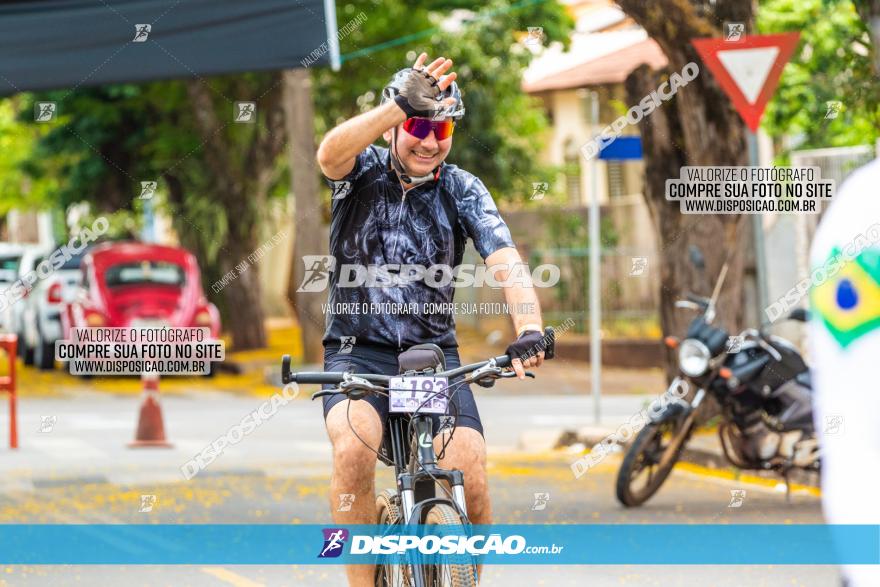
[{"x1": 282, "y1": 68, "x2": 327, "y2": 363}]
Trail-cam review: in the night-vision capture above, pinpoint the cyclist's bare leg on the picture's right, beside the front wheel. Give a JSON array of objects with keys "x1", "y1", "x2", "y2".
[{"x1": 434, "y1": 426, "x2": 492, "y2": 578}]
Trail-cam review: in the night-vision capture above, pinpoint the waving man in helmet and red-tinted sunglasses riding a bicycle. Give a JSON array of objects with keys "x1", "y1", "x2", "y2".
[{"x1": 317, "y1": 53, "x2": 544, "y2": 585}]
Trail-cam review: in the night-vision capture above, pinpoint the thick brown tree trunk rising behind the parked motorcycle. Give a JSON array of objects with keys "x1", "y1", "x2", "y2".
[{"x1": 618, "y1": 0, "x2": 753, "y2": 370}]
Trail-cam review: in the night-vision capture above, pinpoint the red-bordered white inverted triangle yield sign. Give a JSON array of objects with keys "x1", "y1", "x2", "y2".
[{"x1": 691, "y1": 32, "x2": 800, "y2": 132}]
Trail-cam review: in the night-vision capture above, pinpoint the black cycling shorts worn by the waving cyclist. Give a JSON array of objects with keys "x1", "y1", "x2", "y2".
[{"x1": 322, "y1": 345, "x2": 483, "y2": 435}]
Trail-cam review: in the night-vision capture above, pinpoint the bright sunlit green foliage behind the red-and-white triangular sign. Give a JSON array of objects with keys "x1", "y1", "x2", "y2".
[{"x1": 757, "y1": 0, "x2": 880, "y2": 149}]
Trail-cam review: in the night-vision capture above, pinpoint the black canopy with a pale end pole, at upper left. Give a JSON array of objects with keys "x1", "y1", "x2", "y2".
[{"x1": 0, "y1": 0, "x2": 339, "y2": 96}]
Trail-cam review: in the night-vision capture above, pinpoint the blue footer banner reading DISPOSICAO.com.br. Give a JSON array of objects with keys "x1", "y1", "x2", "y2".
[{"x1": 0, "y1": 524, "x2": 880, "y2": 565}]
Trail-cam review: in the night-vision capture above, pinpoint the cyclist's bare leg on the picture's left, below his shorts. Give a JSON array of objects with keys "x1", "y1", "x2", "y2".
[{"x1": 326, "y1": 400, "x2": 382, "y2": 587}]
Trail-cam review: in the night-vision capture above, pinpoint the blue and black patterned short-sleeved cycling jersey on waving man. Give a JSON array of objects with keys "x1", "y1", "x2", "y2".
[{"x1": 324, "y1": 146, "x2": 514, "y2": 349}]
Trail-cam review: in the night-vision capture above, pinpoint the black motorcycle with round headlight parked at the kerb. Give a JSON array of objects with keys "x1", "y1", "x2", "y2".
[{"x1": 616, "y1": 247, "x2": 820, "y2": 507}]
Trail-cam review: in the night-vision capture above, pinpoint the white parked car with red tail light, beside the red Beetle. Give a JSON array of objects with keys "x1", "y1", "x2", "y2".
[{"x1": 18, "y1": 248, "x2": 89, "y2": 370}]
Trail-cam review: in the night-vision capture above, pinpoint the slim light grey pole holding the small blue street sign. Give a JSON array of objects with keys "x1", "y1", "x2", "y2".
[{"x1": 589, "y1": 92, "x2": 602, "y2": 424}]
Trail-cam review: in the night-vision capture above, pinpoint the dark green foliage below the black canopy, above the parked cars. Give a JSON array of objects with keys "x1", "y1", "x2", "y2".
[{"x1": 11, "y1": 73, "x2": 287, "y2": 258}]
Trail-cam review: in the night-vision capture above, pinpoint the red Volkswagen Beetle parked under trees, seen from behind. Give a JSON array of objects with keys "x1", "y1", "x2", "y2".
[{"x1": 62, "y1": 242, "x2": 220, "y2": 338}]
